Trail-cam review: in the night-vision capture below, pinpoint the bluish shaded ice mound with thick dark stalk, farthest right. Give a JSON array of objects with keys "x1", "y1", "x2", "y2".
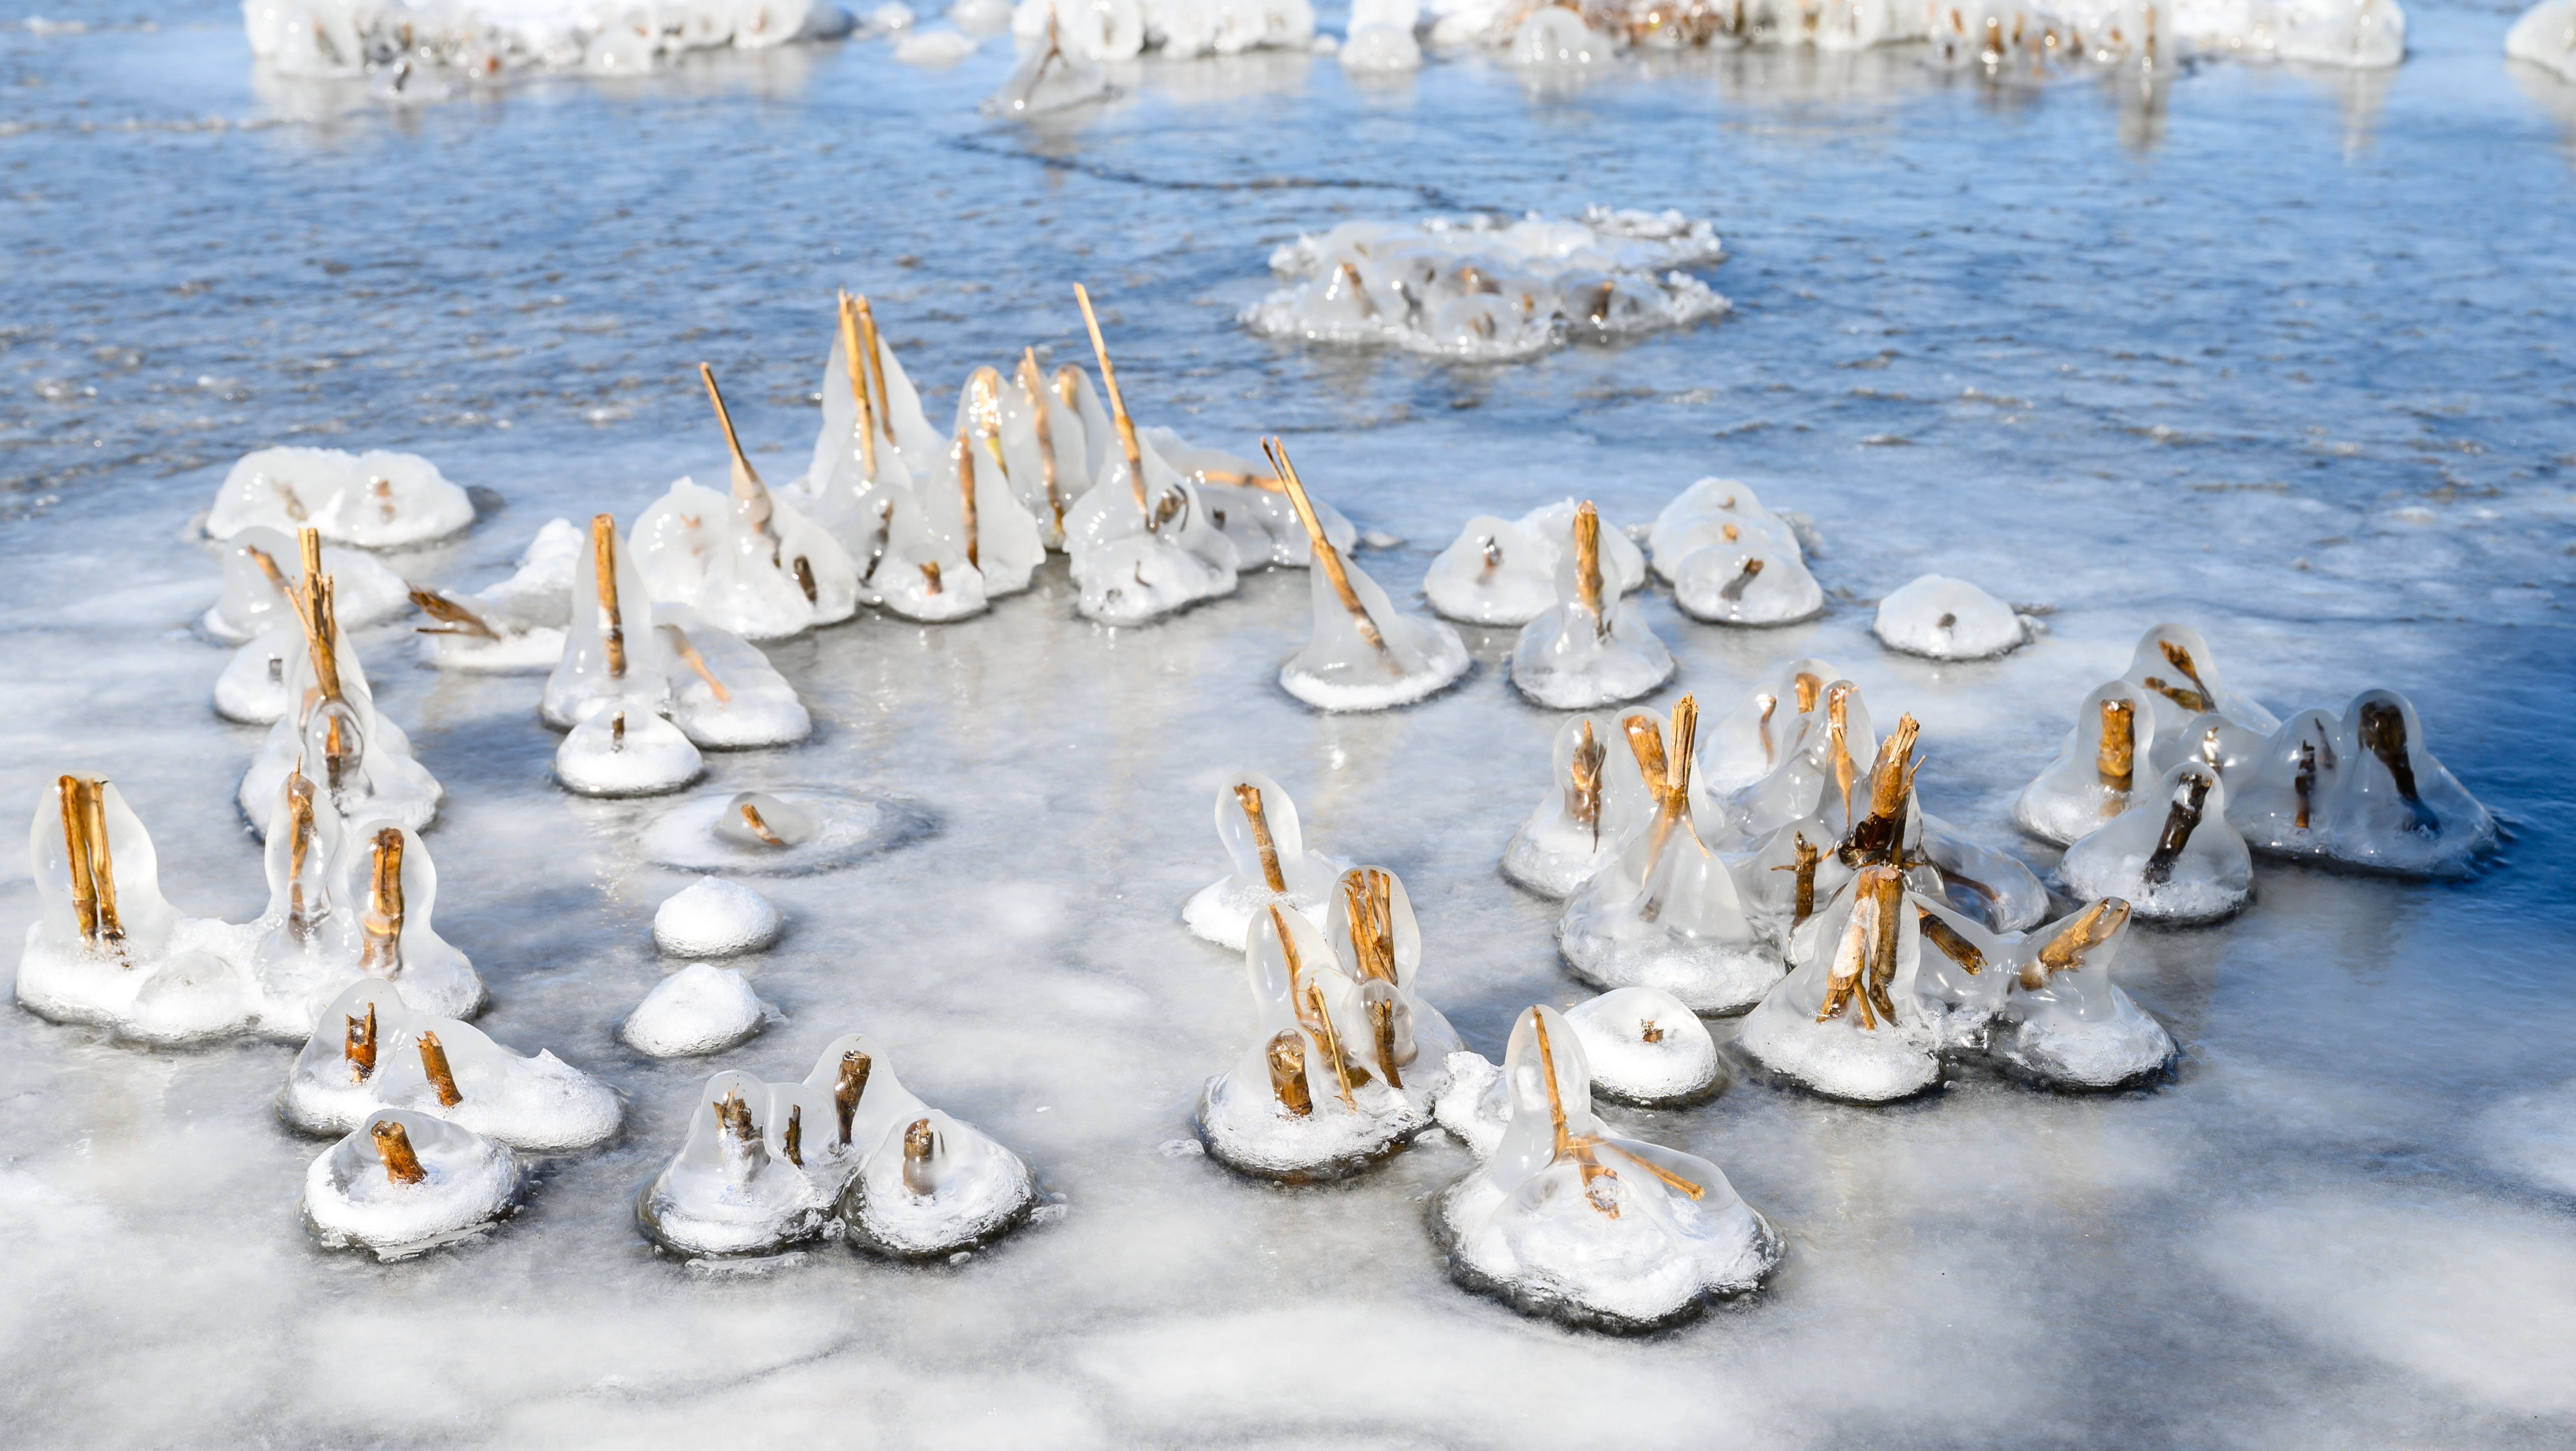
[{"x1": 2223, "y1": 691, "x2": 2496, "y2": 876}]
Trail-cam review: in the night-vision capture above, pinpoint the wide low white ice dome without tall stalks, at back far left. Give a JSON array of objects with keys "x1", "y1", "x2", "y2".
[{"x1": 206, "y1": 448, "x2": 474, "y2": 549}]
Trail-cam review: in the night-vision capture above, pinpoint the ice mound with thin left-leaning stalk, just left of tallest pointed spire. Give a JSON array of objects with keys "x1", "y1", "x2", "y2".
[{"x1": 629, "y1": 363, "x2": 858, "y2": 639}]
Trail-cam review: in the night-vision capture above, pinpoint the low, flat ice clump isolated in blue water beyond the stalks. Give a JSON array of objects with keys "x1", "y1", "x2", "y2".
[{"x1": 1242, "y1": 206, "x2": 1729, "y2": 361}]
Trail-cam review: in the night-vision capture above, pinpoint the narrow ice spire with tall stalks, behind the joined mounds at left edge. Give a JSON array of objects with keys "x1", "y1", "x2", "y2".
[{"x1": 234, "y1": 528, "x2": 441, "y2": 830}]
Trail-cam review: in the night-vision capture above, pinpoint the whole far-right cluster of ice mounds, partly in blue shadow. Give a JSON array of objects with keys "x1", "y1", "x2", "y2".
[{"x1": 2012, "y1": 624, "x2": 2496, "y2": 881}]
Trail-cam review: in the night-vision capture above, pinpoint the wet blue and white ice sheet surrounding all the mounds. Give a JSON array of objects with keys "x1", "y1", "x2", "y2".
[{"x1": 0, "y1": 5, "x2": 2576, "y2": 1446}]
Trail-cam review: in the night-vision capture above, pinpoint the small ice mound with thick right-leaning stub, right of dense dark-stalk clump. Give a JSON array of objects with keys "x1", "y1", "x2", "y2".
[{"x1": 1991, "y1": 897, "x2": 2174, "y2": 1090}]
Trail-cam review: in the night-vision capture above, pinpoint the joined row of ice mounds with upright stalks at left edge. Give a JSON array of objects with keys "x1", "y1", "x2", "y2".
[{"x1": 15, "y1": 773, "x2": 484, "y2": 1044}]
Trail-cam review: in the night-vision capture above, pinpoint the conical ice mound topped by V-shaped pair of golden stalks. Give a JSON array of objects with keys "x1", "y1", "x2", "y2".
[{"x1": 1556, "y1": 696, "x2": 1780, "y2": 1013}]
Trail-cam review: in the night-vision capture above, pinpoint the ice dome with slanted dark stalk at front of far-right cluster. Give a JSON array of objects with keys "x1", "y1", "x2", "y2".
[{"x1": 2058, "y1": 760, "x2": 2254, "y2": 923}]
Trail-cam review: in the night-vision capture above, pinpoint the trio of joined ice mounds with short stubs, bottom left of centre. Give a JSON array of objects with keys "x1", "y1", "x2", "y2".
[{"x1": 636, "y1": 1034, "x2": 1038, "y2": 1258}]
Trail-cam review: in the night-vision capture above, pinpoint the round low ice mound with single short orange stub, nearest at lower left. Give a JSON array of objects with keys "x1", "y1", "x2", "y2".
[{"x1": 304, "y1": 1108, "x2": 520, "y2": 1260}]
